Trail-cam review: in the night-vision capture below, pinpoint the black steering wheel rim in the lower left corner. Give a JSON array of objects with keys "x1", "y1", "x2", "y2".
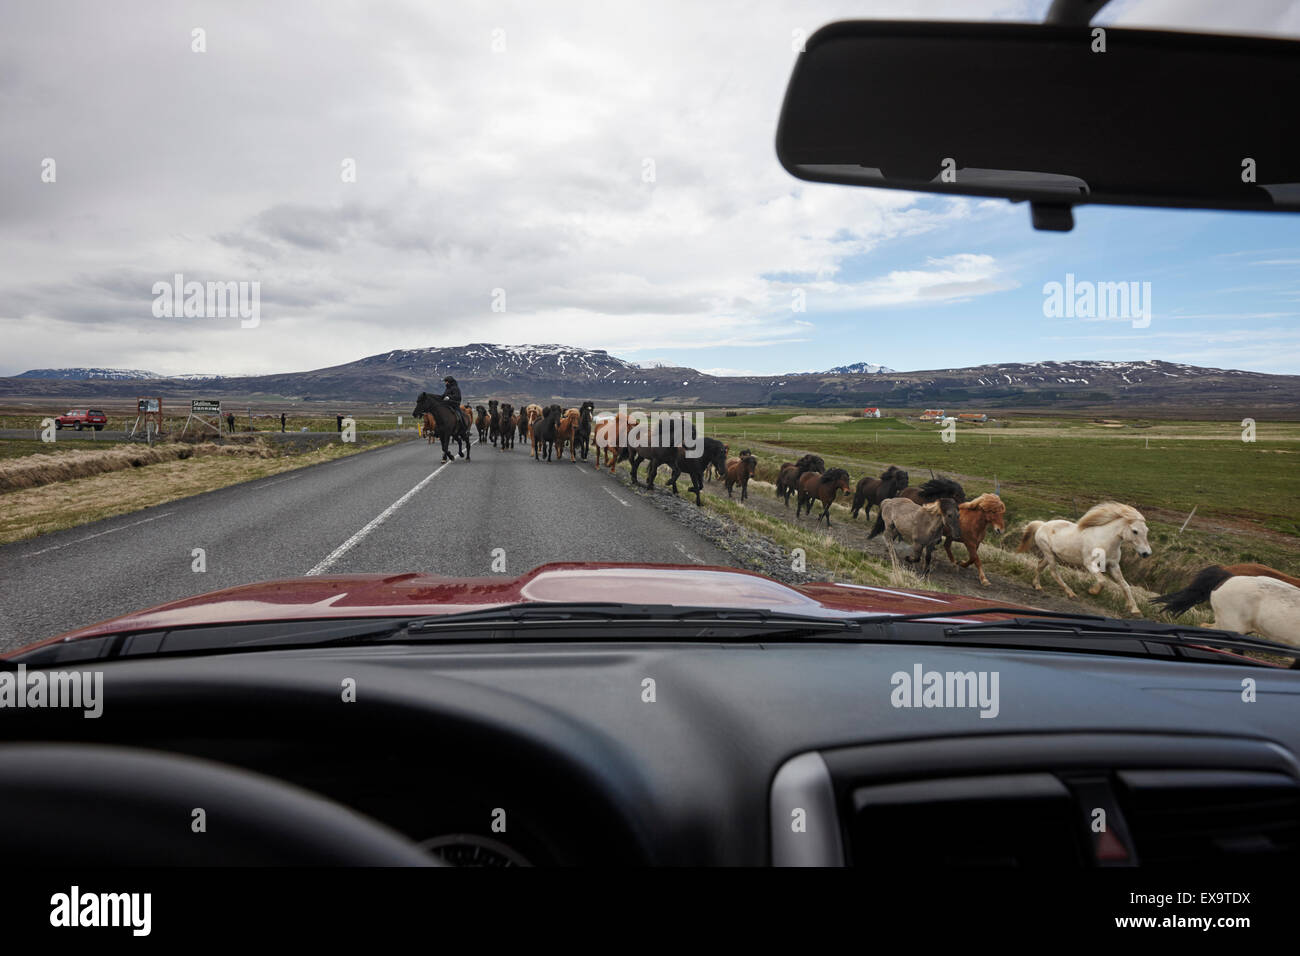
[{"x1": 0, "y1": 744, "x2": 441, "y2": 866}]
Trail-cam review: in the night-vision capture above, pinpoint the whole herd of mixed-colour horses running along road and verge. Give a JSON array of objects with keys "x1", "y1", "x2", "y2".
[{"x1": 415, "y1": 393, "x2": 1300, "y2": 645}]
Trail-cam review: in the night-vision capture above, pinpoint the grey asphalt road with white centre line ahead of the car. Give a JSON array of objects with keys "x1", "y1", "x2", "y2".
[{"x1": 0, "y1": 441, "x2": 729, "y2": 649}]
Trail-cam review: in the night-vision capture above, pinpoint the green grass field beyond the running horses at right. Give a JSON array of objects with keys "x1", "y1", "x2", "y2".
[{"x1": 705, "y1": 410, "x2": 1300, "y2": 592}]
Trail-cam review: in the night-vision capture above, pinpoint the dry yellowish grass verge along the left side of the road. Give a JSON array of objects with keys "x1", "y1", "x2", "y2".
[{"x1": 0, "y1": 440, "x2": 397, "y2": 544}]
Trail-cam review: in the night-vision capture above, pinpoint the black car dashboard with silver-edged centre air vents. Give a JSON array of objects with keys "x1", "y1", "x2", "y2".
[{"x1": 0, "y1": 641, "x2": 1300, "y2": 869}]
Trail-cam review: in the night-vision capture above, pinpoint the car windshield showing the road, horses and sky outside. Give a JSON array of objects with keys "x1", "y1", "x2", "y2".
[{"x1": 0, "y1": 0, "x2": 1300, "y2": 653}]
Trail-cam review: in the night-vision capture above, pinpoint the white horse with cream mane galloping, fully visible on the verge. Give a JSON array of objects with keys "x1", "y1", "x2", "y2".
[{"x1": 1017, "y1": 501, "x2": 1151, "y2": 614}]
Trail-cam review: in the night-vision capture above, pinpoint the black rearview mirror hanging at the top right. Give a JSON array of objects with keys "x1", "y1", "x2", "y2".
[{"x1": 776, "y1": 21, "x2": 1300, "y2": 230}]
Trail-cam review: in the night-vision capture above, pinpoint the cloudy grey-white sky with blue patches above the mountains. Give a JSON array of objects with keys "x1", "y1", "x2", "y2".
[{"x1": 0, "y1": 0, "x2": 1300, "y2": 375}]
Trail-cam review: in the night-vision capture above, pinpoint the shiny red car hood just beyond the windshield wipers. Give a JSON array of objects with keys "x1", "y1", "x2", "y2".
[{"x1": 10, "y1": 563, "x2": 1024, "y2": 657}]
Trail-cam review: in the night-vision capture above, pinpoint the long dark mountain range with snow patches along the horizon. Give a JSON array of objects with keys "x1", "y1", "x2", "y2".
[{"x1": 0, "y1": 343, "x2": 1300, "y2": 418}]
